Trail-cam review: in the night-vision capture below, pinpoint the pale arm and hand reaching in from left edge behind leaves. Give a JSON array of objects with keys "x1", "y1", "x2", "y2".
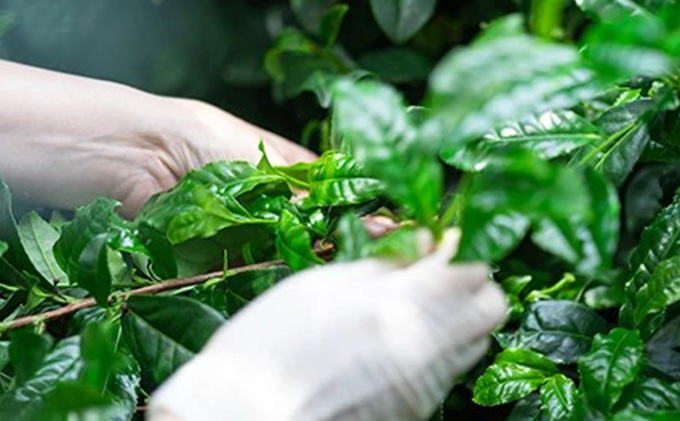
[{"x1": 0, "y1": 61, "x2": 314, "y2": 216}]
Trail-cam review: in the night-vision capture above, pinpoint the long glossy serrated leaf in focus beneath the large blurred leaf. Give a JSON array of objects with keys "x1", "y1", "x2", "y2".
[{"x1": 441, "y1": 111, "x2": 602, "y2": 171}]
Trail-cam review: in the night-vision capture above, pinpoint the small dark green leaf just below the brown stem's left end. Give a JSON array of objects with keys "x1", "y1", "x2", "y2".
[{"x1": 9, "y1": 330, "x2": 52, "y2": 383}]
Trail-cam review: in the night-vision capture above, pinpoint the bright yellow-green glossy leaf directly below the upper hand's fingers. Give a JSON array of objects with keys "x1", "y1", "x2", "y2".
[{"x1": 137, "y1": 161, "x2": 290, "y2": 244}]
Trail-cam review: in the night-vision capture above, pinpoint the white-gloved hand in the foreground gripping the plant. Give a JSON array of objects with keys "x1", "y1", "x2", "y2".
[{"x1": 150, "y1": 231, "x2": 506, "y2": 421}]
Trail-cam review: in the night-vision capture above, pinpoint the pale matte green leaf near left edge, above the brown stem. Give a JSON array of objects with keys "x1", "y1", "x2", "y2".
[{"x1": 17, "y1": 212, "x2": 68, "y2": 285}]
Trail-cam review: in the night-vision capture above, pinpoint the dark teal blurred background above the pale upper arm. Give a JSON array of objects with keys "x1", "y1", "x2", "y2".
[{"x1": 0, "y1": 0, "x2": 520, "y2": 149}]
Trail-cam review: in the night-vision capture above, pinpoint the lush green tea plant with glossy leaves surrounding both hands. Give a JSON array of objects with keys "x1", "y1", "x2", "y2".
[{"x1": 0, "y1": 0, "x2": 680, "y2": 421}]
